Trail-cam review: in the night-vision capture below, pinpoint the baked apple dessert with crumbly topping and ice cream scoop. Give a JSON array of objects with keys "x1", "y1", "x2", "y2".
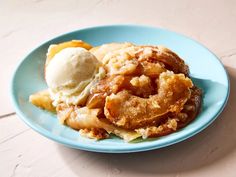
[{"x1": 29, "y1": 40, "x2": 202, "y2": 142}]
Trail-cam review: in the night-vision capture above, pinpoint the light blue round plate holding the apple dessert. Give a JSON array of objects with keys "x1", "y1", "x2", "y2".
[{"x1": 11, "y1": 25, "x2": 229, "y2": 153}]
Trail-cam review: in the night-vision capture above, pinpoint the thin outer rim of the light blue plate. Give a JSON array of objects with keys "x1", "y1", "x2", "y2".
[{"x1": 10, "y1": 24, "x2": 230, "y2": 153}]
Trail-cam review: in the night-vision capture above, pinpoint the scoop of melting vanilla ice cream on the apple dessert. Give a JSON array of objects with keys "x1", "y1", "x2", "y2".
[{"x1": 45, "y1": 47, "x2": 105, "y2": 106}]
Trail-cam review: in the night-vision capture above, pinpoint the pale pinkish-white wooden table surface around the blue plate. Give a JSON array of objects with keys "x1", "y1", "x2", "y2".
[{"x1": 0, "y1": 0, "x2": 236, "y2": 177}]
